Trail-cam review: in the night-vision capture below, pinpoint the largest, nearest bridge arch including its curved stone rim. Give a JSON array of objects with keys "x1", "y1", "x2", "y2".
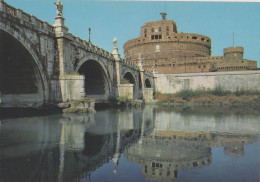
[{"x1": 0, "y1": 25, "x2": 49, "y2": 107}]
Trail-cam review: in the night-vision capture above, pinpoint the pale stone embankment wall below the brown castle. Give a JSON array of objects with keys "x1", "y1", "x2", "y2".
[{"x1": 155, "y1": 71, "x2": 260, "y2": 93}]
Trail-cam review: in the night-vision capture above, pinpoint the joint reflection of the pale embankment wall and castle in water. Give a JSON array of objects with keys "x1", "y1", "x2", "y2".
[{"x1": 125, "y1": 108, "x2": 259, "y2": 181}]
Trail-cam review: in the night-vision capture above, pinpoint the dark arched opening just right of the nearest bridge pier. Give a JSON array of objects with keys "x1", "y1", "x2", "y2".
[{"x1": 78, "y1": 60, "x2": 109, "y2": 99}]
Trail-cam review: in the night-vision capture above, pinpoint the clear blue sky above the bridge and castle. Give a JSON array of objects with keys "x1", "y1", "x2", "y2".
[{"x1": 5, "y1": 0, "x2": 260, "y2": 67}]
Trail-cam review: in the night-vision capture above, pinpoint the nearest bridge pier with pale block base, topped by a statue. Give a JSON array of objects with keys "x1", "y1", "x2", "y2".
[{"x1": 54, "y1": 2, "x2": 94, "y2": 112}]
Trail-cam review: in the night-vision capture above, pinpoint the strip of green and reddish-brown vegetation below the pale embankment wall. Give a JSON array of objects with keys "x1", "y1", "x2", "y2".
[{"x1": 154, "y1": 87, "x2": 260, "y2": 106}]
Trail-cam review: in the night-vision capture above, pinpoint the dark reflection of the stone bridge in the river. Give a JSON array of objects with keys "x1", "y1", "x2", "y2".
[{"x1": 0, "y1": 107, "x2": 154, "y2": 181}]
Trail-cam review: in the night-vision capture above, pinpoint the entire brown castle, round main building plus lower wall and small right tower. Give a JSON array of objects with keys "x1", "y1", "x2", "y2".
[{"x1": 124, "y1": 13, "x2": 257, "y2": 74}]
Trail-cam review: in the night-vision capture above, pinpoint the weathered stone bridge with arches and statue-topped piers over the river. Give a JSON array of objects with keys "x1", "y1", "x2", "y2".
[{"x1": 0, "y1": 0, "x2": 155, "y2": 107}]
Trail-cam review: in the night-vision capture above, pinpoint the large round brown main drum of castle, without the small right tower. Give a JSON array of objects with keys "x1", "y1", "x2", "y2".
[{"x1": 124, "y1": 16, "x2": 211, "y2": 70}]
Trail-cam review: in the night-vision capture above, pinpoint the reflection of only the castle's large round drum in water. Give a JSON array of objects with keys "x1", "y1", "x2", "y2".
[{"x1": 125, "y1": 135, "x2": 211, "y2": 181}]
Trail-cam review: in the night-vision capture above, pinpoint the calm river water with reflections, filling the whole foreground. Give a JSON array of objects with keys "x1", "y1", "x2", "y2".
[{"x1": 0, "y1": 107, "x2": 260, "y2": 182}]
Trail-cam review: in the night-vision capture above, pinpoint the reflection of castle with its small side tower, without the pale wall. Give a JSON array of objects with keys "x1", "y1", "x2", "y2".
[{"x1": 125, "y1": 131, "x2": 257, "y2": 181}]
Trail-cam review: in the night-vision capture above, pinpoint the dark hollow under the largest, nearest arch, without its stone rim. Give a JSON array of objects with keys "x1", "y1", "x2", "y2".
[{"x1": 0, "y1": 30, "x2": 44, "y2": 107}]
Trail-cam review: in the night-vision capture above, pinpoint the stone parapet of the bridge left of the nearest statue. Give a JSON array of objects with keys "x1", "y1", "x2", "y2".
[{"x1": 0, "y1": 2, "x2": 54, "y2": 32}]
